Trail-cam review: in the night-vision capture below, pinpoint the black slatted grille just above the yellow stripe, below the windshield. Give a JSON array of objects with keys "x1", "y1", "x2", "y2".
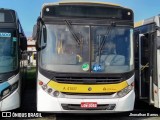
[{"x1": 54, "y1": 77, "x2": 123, "y2": 84}]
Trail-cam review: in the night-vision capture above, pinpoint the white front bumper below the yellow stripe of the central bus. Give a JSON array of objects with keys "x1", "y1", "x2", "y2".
[{"x1": 37, "y1": 89, "x2": 135, "y2": 113}]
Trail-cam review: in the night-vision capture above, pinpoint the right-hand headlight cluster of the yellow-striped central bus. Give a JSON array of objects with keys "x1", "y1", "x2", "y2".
[{"x1": 117, "y1": 83, "x2": 134, "y2": 98}]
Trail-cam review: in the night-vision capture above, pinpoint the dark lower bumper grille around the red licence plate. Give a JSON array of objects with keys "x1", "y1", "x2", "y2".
[{"x1": 61, "y1": 104, "x2": 116, "y2": 110}]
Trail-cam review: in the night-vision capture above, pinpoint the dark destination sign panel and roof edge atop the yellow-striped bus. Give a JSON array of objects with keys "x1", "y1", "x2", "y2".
[{"x1": 40, "y1": 0, "x2": 133, "y2": 20}]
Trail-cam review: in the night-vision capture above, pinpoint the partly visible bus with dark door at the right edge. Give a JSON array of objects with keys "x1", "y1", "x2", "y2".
[{"x1": 134, "y1": 16, "x2": 160, "y2": 108}]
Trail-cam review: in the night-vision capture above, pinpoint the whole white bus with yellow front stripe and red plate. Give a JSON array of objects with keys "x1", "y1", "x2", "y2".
[{"x1": 33, "y1": 2, "x2": 135, "y2": 113}]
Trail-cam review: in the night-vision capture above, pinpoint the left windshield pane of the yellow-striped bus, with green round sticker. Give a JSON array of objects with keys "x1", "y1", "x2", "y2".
[{"x1": 41, "y1": 25, "x2": 89, "y2": 72}]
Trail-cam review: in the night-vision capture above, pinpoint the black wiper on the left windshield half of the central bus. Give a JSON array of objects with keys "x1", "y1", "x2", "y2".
[{"x1": 65, "y1": 20, "x2": 81, "y2": 46}]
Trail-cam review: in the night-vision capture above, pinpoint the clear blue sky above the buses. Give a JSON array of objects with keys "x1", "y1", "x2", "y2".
[{"x1": 0, "y1": 0, "x2": 160, "y2": 37}]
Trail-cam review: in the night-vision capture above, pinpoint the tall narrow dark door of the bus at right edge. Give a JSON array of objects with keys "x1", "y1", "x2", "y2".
[{"x1": 138, "y1": 34, "x2": 150, "y2": 100}]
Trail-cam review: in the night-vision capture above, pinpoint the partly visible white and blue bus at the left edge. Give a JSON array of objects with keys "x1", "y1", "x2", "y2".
[{"x1": 0, "y1": 8, "x2": 27, "y2": 111}]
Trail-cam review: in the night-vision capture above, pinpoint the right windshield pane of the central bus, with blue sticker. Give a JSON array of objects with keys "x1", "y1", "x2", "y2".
[{"x1": 91, "y1": 26, "x2": 133, "y2": 73}]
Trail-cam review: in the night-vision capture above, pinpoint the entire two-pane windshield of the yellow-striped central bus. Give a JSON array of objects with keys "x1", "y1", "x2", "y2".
[{"x1": 40, "y1": 24, "x2": 134, "y2": 73}]
